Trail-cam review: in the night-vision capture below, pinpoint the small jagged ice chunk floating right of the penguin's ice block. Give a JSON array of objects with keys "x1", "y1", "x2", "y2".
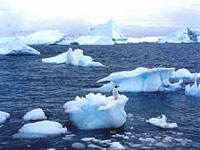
[{"x1": 146, "y1": 115, "x2": 178, "y2": 129}]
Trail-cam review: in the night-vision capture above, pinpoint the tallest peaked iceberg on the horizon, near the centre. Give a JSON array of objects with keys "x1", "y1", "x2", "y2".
[{"x1": 74, "y1": 20, "x2": 122, "y2": 45}]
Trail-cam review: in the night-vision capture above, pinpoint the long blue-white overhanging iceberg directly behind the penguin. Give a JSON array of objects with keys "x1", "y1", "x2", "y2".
[{"x1": 94, "y1": 67, "x2": 183, "y2": 92}]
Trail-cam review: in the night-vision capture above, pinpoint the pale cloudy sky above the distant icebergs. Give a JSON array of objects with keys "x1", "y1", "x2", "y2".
[{"x1": 0, "y1": 0, "x2": 200, "y2": 37}]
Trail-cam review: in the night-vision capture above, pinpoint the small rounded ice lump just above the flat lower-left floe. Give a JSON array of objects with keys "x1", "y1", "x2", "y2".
[{"x1": 23, "y1": 108, "x2": 47, "y2": 121}]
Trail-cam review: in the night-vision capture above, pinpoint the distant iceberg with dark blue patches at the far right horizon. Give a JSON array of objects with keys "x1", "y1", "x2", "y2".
[{"x1": 158, "y1": 27, "x2": 200, "y2": 43}]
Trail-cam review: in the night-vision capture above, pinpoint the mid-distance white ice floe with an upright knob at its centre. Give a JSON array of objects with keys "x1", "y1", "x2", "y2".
[{"x1": 42, "y1": 48, "x2": 103, "y2": 66}]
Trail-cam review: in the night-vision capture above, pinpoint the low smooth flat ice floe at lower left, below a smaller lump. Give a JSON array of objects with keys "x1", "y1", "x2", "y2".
[{"x1": 14, "y1": 120, "x2": 67, "y2": 138}]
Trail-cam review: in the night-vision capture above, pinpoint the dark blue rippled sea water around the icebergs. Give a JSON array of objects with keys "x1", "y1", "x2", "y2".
[{"x1": 0, "y1": 43, "x2": 200, "y2": 150}]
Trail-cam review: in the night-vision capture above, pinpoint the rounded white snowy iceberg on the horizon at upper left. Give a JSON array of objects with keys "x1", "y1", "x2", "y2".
[{"x1": 19, "y1": 30, "x2": 65, "y2": 45}]
